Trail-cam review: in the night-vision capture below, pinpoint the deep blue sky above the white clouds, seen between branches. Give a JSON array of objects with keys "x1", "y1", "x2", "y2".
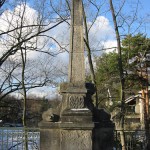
[{"x1": 4, "y1": 0, "x2": 150, "y2": 37}]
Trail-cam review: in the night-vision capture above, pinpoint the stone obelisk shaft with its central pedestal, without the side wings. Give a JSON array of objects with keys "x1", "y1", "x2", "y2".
[{"x1": 60, "y1": 0, "x2": 94, "y2": 150}]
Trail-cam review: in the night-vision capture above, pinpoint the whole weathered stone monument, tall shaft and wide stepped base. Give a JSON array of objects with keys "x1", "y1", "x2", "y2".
[{"x1": 39, "y1": 0, "x2": 112, "y2": 150}]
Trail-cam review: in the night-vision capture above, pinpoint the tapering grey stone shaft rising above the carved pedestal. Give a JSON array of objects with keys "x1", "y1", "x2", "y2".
[{"x1": 69, "y1": 0, "x2": 85, "y2": 83}]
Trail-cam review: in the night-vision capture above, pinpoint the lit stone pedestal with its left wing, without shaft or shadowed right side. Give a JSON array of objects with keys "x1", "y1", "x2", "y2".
[{"x1": 39, "y1": 83, "x2": 94, "y2": 150}]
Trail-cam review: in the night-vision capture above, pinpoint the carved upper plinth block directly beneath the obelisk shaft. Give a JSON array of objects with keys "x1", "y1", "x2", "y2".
[{"x1": 60, "y1": 82, "x2": 94, "y2": 113}]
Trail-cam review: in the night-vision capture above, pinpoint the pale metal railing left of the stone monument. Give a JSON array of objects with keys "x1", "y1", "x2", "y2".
[{"x1": 0, "y1": 127, "x2": 40, "y2": 150}]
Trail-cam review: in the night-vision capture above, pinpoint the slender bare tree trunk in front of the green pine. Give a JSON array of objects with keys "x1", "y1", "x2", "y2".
[{"x1": 109, "y1": 0, "x2": 126, "y2": 150}]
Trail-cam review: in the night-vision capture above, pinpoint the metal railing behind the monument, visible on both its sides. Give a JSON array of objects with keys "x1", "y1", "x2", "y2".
[{"x1": 0, "y1": 127, "x2": 146, "y2": 150}]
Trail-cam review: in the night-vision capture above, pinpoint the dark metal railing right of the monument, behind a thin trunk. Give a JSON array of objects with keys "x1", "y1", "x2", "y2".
[{"x1": 114, "y1": 130, "x2": 146, "y2": 150}]
